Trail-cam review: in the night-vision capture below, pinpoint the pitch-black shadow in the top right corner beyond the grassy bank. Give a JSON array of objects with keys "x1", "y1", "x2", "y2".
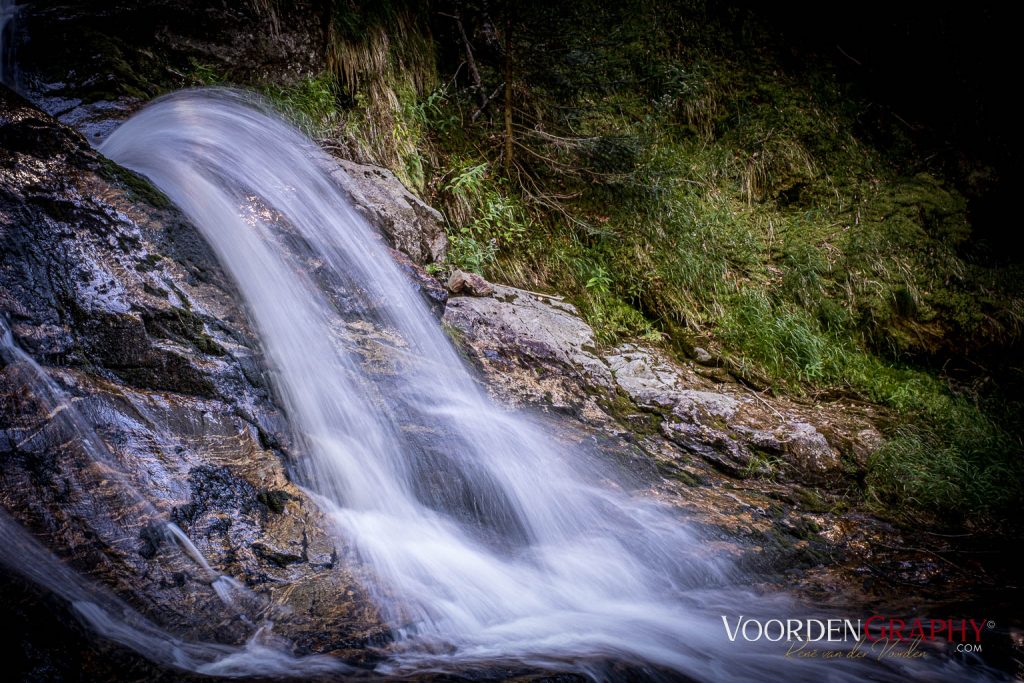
[{"x1": 741, "y1": 0, "x2": 1024, "y2": 262}]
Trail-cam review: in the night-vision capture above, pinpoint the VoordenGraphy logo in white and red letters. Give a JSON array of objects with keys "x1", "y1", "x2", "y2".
[{"x1": 722, "y1": 614, "x2": 995, "y2": 658}]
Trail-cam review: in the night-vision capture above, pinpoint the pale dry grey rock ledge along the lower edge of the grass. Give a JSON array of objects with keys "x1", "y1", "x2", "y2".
[{"x1": 443, "y1": 286, "x2": 882, "y2": 483}]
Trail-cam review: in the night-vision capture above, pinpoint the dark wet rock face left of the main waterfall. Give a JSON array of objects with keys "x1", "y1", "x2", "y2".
[{"x1": 0, "y1": 89, "x2": 386, "y2": 659}]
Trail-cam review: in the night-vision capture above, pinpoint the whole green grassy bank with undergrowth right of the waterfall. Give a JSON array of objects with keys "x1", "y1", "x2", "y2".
[{"x1": 222, "y1": 0, "x2": 1024, "y2": 519}]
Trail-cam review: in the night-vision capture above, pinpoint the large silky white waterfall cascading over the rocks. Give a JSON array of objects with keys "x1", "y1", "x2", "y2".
[{"x1": 94, "y1": 90, "x2": 991, "y2": 681}]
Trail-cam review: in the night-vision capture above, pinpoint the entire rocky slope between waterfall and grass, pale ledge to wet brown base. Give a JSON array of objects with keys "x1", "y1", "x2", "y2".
[{"x1": 442, "y1": 285, "x2": 1009, "y2": 608}]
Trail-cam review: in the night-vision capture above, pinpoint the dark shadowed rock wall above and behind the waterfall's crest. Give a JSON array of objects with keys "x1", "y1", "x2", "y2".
[{"x1": 17, "y1": 0, "x2": 328, "y2": 139}]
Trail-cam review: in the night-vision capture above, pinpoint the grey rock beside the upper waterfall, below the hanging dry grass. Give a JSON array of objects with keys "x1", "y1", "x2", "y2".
[{"x1": 335, "y1": 160, "x2": 447, "y2": 265}]
